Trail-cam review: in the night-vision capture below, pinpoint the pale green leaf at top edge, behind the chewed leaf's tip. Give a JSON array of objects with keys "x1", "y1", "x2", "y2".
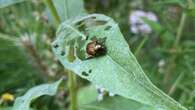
[{"x1": 53, "y1": 0, "x2": 86, "y2": 21}]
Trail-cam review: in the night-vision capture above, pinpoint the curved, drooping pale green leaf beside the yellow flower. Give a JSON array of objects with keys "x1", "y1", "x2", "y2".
[{"x1": 13, "y1": 79, "x2": 62, "y2": 110}]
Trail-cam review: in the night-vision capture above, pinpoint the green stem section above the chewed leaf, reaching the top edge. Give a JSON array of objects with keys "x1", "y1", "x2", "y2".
[{"x1": 44, "y1": 0, "x2": 61, "y2": 26}]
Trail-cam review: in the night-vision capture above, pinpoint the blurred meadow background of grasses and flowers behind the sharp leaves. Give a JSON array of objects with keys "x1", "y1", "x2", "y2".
[{"x1": 0, "y1": 0, "x2": 195, "y2": 110}]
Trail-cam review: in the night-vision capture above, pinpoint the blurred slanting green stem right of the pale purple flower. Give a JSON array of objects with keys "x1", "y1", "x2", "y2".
[{"x1": 174, "y1": 12, "x2": 187, "y2": 48}]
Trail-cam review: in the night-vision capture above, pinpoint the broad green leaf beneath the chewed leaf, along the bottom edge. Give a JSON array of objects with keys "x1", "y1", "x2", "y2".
[{"x1": 78, "y1": 85, "x2": 155, "y2": 110}]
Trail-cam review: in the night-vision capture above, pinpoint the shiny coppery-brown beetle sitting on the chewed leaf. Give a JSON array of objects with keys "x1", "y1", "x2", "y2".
[{"x1": 86, "y1": 38, "x2": 107, "y2": 58}]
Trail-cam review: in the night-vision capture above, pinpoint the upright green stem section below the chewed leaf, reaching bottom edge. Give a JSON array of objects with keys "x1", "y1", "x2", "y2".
[{"x1": 68, "y1": 71, "x2": 77, "y2": 110}]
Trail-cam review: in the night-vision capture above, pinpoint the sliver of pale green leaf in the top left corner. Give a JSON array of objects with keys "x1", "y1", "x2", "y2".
[{"x1": 0, "y1": 0, "x2": 26, "y2": 8}]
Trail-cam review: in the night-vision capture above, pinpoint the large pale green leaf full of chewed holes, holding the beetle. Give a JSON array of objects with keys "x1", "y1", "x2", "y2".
[{"x1": 53, "y1": 14, "x2": 186, "y2": 110}]
